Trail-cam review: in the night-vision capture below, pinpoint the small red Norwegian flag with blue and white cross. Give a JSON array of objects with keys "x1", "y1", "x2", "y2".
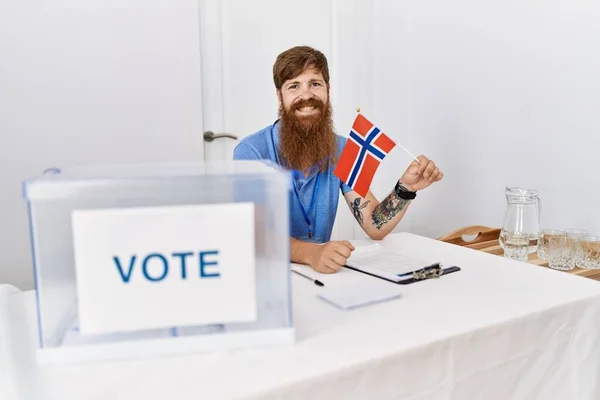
[{"x1": 333, "y1": 114, "x2": 396, "y2": 197}]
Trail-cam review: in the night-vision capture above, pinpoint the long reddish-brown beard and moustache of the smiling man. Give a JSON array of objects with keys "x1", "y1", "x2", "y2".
[{"x1": 279, "y1": 98, "x2": 337, "y2": 171}]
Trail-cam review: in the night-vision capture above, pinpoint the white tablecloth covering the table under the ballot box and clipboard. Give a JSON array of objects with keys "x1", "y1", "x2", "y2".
[{"x1": 3, "y1": 233, "x2": 600, "y2": 400}]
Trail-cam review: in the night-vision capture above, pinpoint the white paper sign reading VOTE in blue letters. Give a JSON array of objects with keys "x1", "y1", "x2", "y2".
[{"x1": 72, "y1": 203, "x2": 257, "y2": 334}]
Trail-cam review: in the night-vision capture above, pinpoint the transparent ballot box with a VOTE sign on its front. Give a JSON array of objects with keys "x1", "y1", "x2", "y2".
[{"x1": 24, "y1": 161, "x2": 294, "y2": 363}]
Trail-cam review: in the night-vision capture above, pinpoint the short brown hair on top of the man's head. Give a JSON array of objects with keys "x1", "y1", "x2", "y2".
[{"x1": 273, "y1": 46, "x2": 329, "y2": 90}]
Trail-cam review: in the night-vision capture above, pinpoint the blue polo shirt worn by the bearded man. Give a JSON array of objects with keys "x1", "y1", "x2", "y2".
[{"x1": 233, "y1": 120, "x2": 351, "y2": 243}]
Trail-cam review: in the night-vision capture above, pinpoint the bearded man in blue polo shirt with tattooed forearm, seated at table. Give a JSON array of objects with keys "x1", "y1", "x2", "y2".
[{"x1": 233, "y1": 46, "x2": 443, "y2": 273}]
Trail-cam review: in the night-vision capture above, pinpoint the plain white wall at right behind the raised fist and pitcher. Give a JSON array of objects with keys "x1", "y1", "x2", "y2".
[{"x1": 373, "y1": 0, "x2": 600, "y2": 241}]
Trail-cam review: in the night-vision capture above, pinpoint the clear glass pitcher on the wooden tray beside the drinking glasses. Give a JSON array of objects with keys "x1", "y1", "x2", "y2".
[{"x1": 499, "y1": 187, "x2": 542, "y2": 253}]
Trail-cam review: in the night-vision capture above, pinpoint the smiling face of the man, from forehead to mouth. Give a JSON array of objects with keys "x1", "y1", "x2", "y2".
[{"x1": 278, "y1": 68, "x2": 329, "y2": 121}]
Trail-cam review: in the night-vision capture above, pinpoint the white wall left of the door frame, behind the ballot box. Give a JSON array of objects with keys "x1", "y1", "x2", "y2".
[{"x1": 0, "y1": 0, "x2": 203, "y2": 289}]
